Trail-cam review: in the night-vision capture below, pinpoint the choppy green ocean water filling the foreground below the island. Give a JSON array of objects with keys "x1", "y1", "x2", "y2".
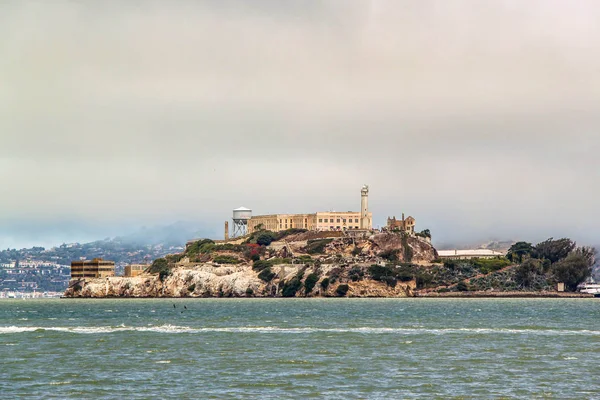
[{"x1": 0, "y1": 299, "x2": 600, "y2": 399}]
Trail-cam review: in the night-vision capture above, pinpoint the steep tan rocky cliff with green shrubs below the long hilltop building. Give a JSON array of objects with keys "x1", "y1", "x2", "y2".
[{"x1": 64, "y1": 232, "x2": 437, "y2": 297}]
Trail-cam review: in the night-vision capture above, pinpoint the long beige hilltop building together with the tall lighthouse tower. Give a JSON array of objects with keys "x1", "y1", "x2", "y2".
[{"x1": 248, "y1": 185, "x2": 373, "y2": 233}]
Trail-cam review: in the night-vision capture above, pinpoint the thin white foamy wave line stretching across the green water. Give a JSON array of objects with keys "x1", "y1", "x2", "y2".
[{"x1": 0, "y1": 324, "x2": 600, "y2": 336}]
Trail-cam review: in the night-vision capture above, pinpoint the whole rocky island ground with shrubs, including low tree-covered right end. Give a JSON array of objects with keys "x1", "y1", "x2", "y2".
[{"x1": 64, "y1": 229, "x2": 593, "y2": 298}]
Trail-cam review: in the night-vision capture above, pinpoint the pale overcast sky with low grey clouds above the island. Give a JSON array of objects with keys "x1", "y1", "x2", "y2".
[{"x1": 0, "y1": 0, "x2": 600, "y2": 248}]
